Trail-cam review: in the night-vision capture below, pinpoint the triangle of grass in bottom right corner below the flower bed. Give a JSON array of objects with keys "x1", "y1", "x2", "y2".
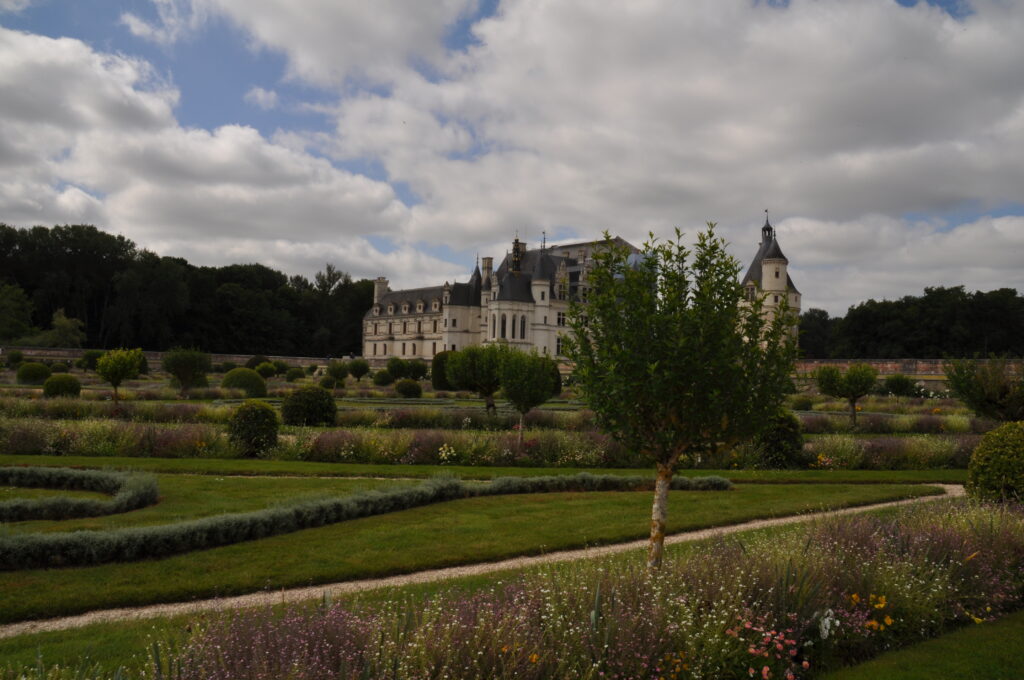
[{"x1": 823, "y1": 611, "x2": 1024, "y2": 680}]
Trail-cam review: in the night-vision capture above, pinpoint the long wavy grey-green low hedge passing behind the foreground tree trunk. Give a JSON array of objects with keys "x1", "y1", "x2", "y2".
[{"x1": 0, "y1": 472, "x2": 732, "y2": 570}]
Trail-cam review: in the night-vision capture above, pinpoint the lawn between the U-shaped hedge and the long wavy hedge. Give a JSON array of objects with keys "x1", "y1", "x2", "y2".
[{"x1": 0, "y1": 474, "x2": 418, "y2": 534}]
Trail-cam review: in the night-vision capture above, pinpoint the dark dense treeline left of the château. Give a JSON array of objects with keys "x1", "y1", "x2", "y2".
[{"x1": 0, "y1": 223, "x2": 373, "y2": 356}]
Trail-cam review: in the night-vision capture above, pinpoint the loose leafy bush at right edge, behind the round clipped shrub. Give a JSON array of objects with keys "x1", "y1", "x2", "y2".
[{"x1": 945, "y1": 355, "x2": 1024, "y2": 421}]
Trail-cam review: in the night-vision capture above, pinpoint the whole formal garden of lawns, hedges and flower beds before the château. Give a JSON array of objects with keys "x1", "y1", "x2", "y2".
[{"x1": 0, "y1": 232, "x2": 1024, "y2": 680}]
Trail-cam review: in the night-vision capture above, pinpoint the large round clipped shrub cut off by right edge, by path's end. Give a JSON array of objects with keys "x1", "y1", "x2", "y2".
[{"x1": 967, "y1": 422, "x2": 1024, "y2": 502}]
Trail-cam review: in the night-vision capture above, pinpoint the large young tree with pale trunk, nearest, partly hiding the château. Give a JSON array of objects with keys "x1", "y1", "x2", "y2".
[{"x1": 563, "y1": 228, "x2": 796, "y2": 568}]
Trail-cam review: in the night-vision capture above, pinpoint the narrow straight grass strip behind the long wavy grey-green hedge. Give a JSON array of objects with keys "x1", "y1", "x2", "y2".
[{"x1": 0, "y1": 455, "x2": 967, "y2": 484}]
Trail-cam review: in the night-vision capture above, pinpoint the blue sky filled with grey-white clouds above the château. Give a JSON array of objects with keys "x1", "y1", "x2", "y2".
[{"x1": 0, "y1": 0, "x2": 1024, "y2": 314}]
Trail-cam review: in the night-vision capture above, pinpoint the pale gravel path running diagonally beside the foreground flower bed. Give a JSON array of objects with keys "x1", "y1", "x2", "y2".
[{"x1": 0, "y1": 484, "x2": 964, "y2": 639}]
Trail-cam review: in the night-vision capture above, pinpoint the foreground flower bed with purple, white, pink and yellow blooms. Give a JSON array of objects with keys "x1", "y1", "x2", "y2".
[{"x1": 163, "y1": 502, "x2": 1024, "y2": 680}]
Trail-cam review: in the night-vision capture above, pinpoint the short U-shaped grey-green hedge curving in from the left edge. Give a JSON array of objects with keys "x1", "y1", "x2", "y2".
[{"x1": 0, "y1": 467, "x2": 159, "y2": 522}]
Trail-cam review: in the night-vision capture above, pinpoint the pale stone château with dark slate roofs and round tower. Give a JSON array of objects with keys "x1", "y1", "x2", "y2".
[{"x1": 362, "y1": 218, "x2": 800, "y2": 366}]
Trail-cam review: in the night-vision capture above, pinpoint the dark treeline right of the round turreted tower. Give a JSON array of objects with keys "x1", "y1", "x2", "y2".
[{"x1": 800, "y1": 286, "x2": 1024, "y2": 358}]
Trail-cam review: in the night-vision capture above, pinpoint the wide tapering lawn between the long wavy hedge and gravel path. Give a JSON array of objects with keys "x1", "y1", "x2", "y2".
[{"x1": 0, "y1": 484, "x2": 936, "y2": 623}]
